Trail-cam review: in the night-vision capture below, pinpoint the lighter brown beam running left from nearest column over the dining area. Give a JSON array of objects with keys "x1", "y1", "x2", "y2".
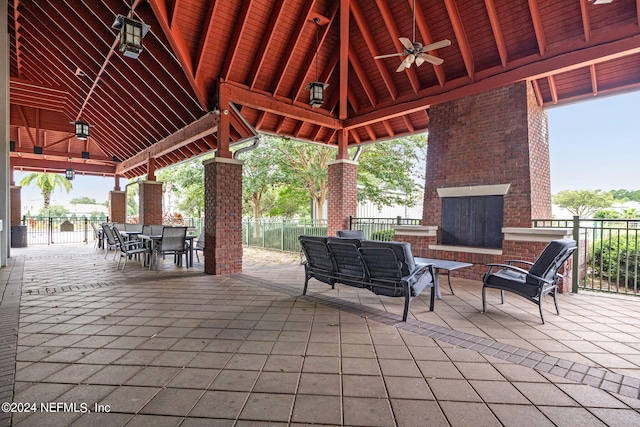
[{"x1": 116, "y1": 113, "x2": 220, "y2": 174}]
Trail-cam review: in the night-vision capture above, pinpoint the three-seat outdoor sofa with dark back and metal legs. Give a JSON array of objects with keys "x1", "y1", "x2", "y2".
[{"x1": 298, "y1": 235, "x2": 435, "y2": 322}]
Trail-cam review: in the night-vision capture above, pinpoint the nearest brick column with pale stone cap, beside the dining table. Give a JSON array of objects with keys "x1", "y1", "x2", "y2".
[{"x1": 203, "y1": 157, "x2": 242, "y2": 274}]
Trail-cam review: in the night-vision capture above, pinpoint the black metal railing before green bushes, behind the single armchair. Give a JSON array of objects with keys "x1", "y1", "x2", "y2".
[{"x1": 533, "y1": 217, "x2": 640, "y2": 295}]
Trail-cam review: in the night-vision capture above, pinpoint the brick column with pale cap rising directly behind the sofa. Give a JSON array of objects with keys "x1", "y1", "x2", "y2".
[{"x1": 327, "y1": 159, "x2": 358, "y2": 236}]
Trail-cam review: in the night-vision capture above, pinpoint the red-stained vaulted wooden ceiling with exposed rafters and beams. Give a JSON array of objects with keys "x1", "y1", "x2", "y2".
[{"x1": 8, "y1": 0, "x2": 640, "y2": 178}]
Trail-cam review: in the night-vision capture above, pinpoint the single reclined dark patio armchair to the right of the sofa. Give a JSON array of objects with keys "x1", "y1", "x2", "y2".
[{"x1": 482, "y1": 239, "x2": 577, "y2": 324}]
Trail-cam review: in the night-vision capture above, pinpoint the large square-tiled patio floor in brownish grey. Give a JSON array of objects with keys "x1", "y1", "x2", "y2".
[{"x1": 0, "y1": 245, "x2": 640, "y2": 426}]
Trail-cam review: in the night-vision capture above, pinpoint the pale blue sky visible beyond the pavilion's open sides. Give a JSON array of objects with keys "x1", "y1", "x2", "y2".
[{"x1": 14, "y1": 92, "x2": 640, "y2": 206}]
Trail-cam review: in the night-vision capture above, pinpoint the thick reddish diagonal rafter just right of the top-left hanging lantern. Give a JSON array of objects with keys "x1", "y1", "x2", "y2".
[{"x1": 148, "y1": 0, "x2": 208, "y2": 111}]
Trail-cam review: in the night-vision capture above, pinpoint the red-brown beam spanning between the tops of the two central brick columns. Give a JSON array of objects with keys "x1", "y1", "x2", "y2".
[{"x1": 220, "y1": 82, "x2": 340, "y2": 129}]
